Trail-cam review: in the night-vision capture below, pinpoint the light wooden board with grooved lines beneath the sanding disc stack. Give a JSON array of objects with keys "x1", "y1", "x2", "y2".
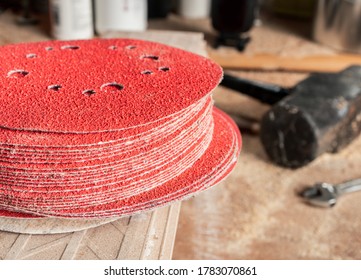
[{"x1": 0, "y1": 203, "x2": 180, "y2": 260}]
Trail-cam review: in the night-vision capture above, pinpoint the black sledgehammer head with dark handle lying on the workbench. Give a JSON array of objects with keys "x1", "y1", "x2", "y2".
[{"x1": 221, "y1": 65, "x2": 361, "y2": 168}]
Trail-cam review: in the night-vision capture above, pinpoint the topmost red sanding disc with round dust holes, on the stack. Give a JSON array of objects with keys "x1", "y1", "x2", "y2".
[{"x1": 0, "y1": 39, "x2": 222, "y2": 133}]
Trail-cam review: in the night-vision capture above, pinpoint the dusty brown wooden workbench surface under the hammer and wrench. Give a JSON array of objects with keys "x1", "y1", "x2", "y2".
[{"x1": 0, "y1": 10, "x2": 361, "y2": 259}]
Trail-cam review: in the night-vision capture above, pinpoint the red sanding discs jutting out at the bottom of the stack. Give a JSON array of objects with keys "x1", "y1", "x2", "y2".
[{"x1": 0, "y1": 109, "x2": 242, "y2": 218}]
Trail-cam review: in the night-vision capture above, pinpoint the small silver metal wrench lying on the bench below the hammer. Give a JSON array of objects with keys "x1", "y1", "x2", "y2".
[{"x1": 301, "y1": 179, "x2": 361, "y2": 207}]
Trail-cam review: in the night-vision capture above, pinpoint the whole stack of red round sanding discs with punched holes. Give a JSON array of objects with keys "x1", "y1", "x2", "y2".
[{"x1": 0, "y1": 39, "x2": 241, "y2": 218}]
